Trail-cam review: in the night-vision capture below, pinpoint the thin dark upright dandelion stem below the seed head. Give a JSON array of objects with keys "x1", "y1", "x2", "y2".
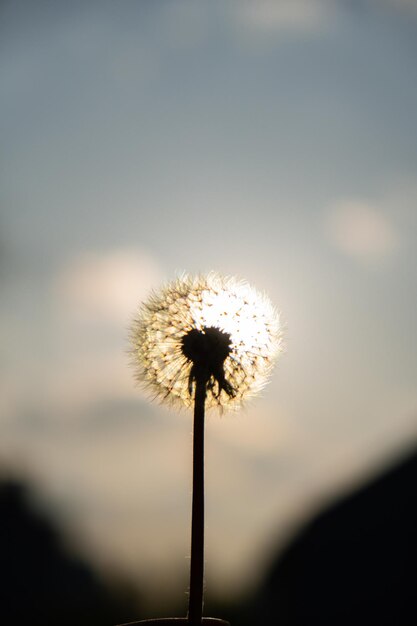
[{"x1": 188, "y1": 376, "x2": 207, "y2": 626}]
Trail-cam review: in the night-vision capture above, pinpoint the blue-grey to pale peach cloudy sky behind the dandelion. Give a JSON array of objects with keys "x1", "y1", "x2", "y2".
[{"x1": 0, "y1": 0, "x2": 417, "y2": 596}]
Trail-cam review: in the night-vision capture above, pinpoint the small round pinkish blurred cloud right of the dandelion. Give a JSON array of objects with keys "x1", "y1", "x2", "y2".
[{"x1": 325, "y1": 200, "x2": 399, "y2": 265}]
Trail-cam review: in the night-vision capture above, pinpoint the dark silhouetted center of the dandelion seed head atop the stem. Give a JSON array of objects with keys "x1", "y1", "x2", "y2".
[{"x1": 181, "y1": 326, "x2": 231, "y2": 373}]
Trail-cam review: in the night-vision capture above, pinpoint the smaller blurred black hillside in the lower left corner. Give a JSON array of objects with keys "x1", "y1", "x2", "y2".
[{"x1": 0, "y1": 481, "x2": 138, "y2": 626}]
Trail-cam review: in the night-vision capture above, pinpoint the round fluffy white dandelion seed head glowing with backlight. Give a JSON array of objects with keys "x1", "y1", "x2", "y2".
[{"x1": 131, "y1": 273, "x2": 282, "y2": 409}]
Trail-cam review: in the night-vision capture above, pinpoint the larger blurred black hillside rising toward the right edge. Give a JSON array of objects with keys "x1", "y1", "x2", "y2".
[{"x1": 228, "y1": 442, "x2": 417, "y2": 626}]
